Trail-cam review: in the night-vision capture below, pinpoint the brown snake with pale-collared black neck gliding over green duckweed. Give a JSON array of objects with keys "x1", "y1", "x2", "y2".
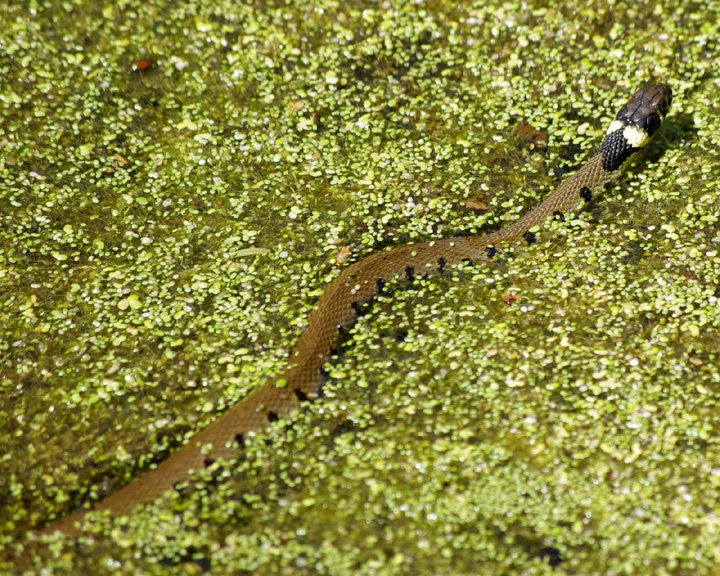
[{"x1": 41, "y1": 84, "x2": 671, "y2": 536}]
